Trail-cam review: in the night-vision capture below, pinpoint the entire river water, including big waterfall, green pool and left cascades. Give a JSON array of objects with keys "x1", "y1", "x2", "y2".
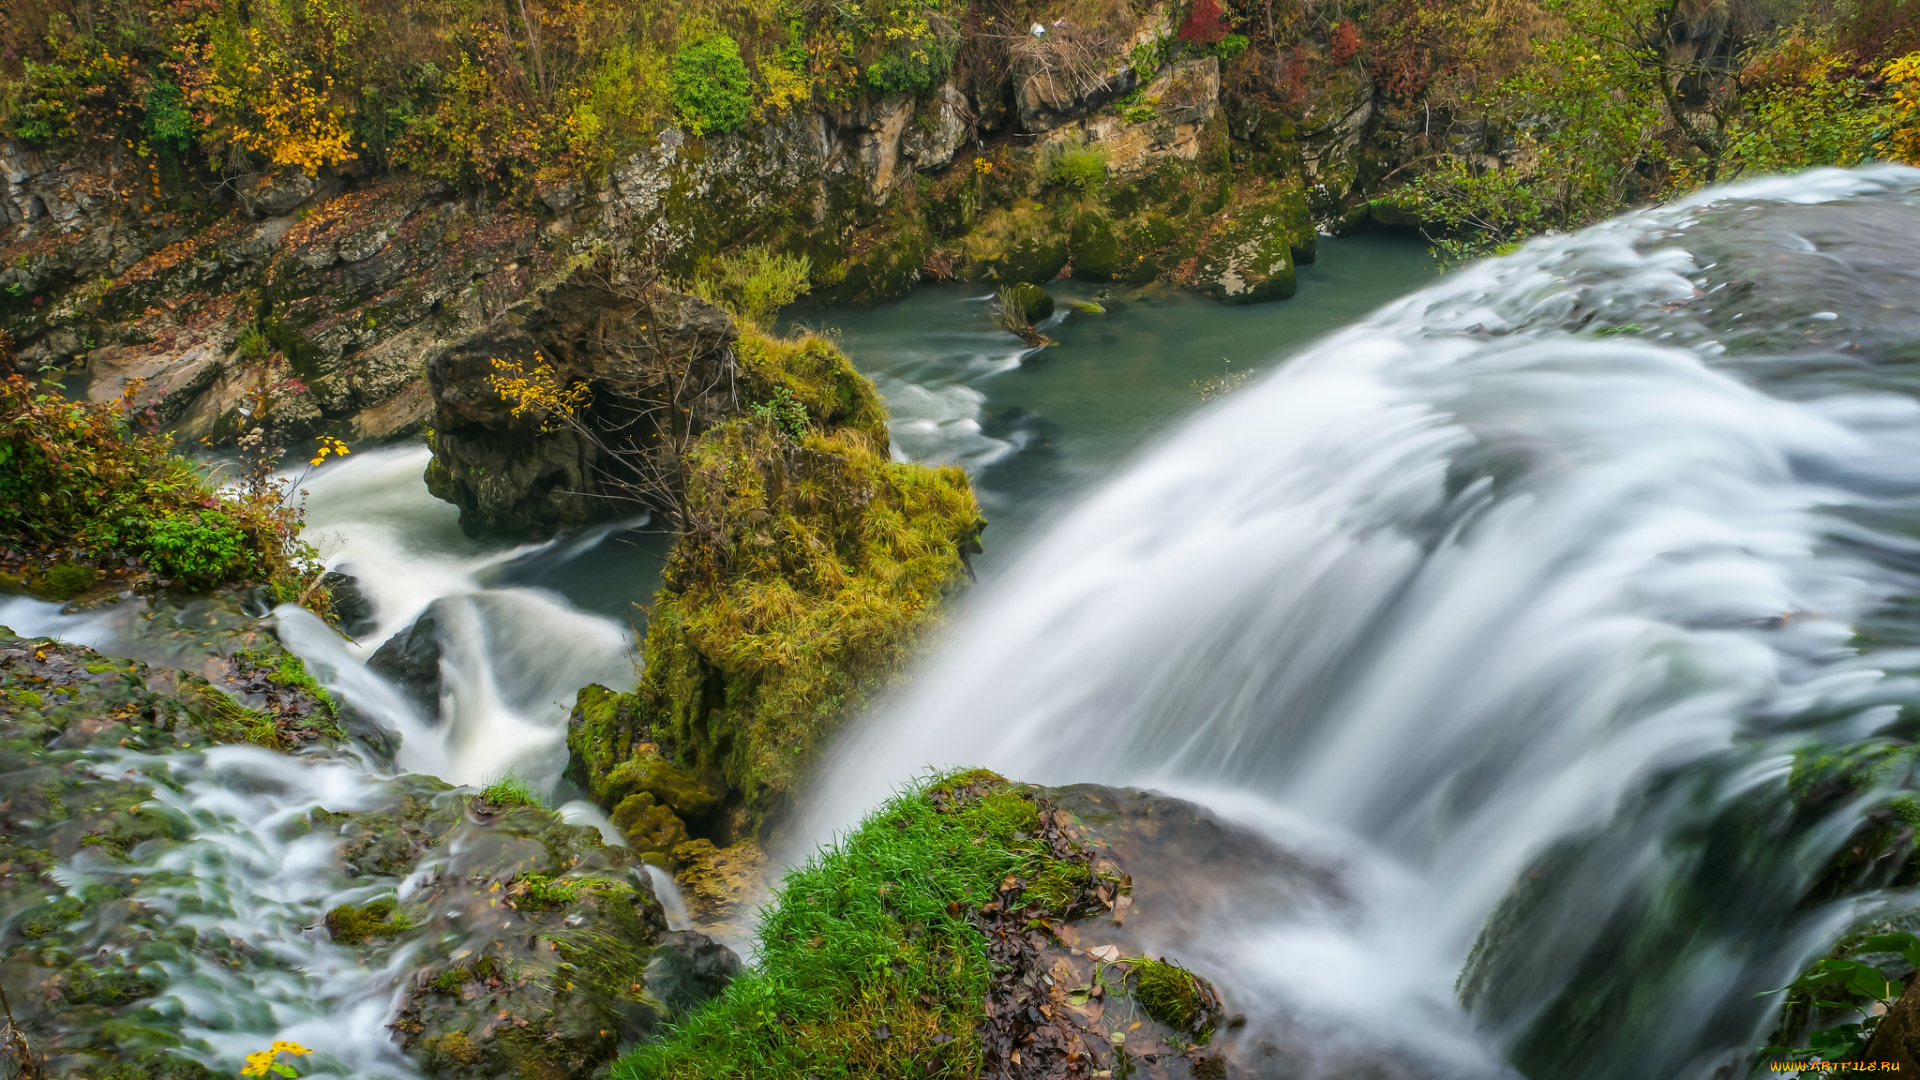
[{"x1": 11, "y1": 169, "x2": 1920, "y2": 1080}]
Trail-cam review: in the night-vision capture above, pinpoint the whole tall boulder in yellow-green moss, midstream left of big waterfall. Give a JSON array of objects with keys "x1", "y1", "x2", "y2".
[{"x1": 566, "y1": 336, "x2": 985, "y2": 826}]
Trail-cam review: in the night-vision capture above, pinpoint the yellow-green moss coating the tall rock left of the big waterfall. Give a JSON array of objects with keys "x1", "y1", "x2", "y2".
[{"x1": 636, "y1": 407, "x2": 985, "y2": 815}]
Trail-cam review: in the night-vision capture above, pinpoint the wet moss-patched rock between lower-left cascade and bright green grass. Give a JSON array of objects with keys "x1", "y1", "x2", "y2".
[{"x1": 369, "y1": 796, "x2": 739, "y2": 1080}]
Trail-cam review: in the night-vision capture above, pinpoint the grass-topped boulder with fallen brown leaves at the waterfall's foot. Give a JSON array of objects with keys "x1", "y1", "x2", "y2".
[{"x1": 614, "y1": 771, "x2": 1259, "y2": 1080}]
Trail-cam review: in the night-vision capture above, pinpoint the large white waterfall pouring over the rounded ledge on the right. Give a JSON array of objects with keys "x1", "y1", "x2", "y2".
[{"x1": 799, "y1": 167, "x2": 1920, "y2": 1078}]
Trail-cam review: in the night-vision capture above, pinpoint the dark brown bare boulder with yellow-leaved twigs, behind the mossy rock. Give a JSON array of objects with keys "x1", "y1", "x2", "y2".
[{"x1": 426, "y1": 259, "x2": 741, "y2": 538}]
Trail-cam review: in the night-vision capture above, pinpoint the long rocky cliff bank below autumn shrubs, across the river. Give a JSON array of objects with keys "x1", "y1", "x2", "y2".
[{"x1": 0, "y1": 6, "x2": 1415, "y2": 445}]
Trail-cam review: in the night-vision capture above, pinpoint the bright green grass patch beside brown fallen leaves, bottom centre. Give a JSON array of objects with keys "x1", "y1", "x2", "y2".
[{"x1": 612, "y1": 771, "x2": 1085, "y2": 1080}]
